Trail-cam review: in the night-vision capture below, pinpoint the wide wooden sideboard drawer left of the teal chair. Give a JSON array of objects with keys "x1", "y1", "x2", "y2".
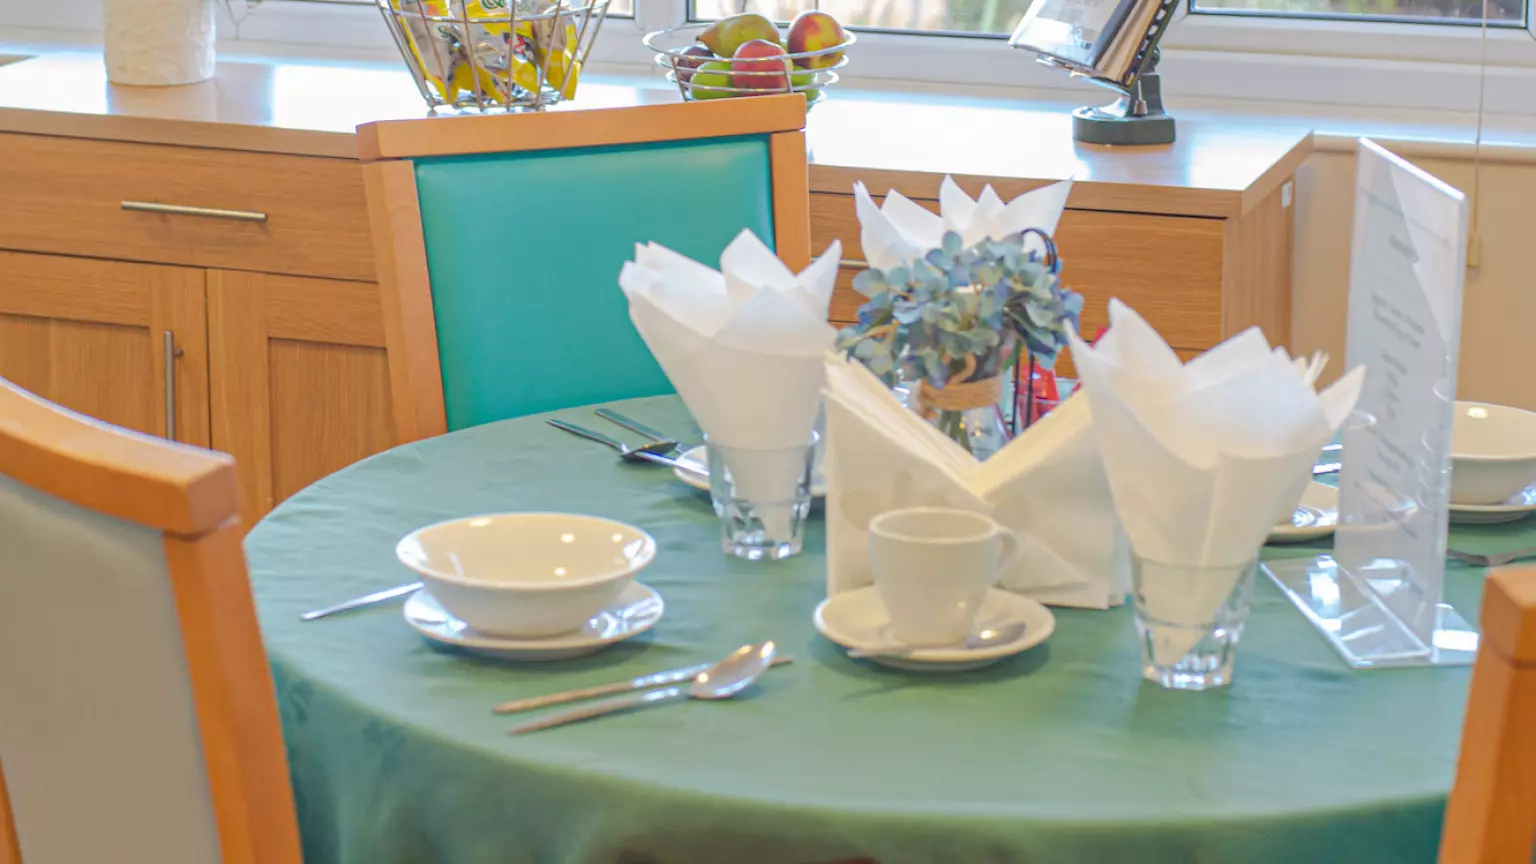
[{"x1": 0, "y1": 135, "x2": 373, "y2": 280}]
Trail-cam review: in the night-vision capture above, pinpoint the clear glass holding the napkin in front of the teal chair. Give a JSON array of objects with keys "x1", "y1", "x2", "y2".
[{"x1": 705, "y1": 432, "x2": 817, "y2": 561}]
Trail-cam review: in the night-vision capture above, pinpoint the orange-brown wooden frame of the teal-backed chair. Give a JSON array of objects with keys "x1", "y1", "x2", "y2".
[{"x1": 358, "y1": 94, "x2": 811, "y2": 443}]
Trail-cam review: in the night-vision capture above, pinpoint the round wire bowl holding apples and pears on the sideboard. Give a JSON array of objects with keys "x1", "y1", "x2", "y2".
[{"x1": 644, "y1": 22, "x2": 859, "y2": 106}]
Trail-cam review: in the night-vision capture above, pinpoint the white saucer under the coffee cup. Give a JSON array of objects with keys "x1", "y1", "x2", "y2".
[{"x1": 816, "y1": 586, "x2": 1055, "y2": 672}]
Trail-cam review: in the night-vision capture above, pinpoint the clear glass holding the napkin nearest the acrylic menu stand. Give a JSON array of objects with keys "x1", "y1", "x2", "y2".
[{"x1": 1132, "y1": 555, "x2": 1258, "y2": 690}]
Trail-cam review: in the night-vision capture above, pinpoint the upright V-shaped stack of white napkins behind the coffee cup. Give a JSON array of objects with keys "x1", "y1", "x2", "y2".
[{"x1": 825, "y1": 354, "x2": 1130, "y2": 609}]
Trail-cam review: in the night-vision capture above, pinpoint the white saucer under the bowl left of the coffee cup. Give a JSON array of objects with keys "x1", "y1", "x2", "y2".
[{"x1": 406, "y1": 583, "x2": 667, "y2": 663}]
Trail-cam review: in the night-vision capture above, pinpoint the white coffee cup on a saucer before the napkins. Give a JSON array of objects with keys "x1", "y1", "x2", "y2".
[{"x1": 869, "y1": 507, "x2": 1018, "y2": 646}]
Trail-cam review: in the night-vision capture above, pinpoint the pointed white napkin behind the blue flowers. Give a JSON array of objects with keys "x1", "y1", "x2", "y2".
[{"x1": 854, "y1": 177, "x2": 1072, "y2": 279}]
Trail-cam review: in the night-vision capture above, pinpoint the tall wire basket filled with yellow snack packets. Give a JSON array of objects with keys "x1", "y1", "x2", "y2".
[{"x1": 375, "y1": 0, "x2": 610, "y2": 114}]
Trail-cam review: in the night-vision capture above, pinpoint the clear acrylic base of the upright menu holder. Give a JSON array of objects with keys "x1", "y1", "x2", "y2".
[{"x1": 1264, "y1": 555, "x2": 1478, "y2": 669}]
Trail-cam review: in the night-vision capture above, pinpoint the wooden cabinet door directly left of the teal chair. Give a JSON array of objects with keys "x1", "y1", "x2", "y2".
[{"x1": 207, "y1": 271, "x2": 395, "y2": 526}]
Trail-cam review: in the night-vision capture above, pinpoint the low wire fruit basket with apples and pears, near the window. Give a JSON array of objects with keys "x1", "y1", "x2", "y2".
[{"x1": 644, "y1": 23, "x2": 859, "y2": 108}]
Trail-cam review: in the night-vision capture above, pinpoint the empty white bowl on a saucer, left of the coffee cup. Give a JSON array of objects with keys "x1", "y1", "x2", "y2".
[{"x1": 395, "y1": 513, "x2": 656, "y2": 638}]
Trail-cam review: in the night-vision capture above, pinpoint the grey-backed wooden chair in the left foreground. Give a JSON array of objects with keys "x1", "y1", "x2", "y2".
[{"x1": 0, "y1": 380, "x2": 300, "y2": 864}]
